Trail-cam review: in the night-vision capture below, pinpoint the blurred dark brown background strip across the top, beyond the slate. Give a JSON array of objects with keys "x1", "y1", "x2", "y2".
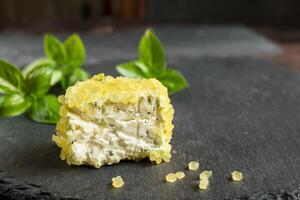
[{"x1": 0, "y1": 0, "x2": 300, "y2": 31}]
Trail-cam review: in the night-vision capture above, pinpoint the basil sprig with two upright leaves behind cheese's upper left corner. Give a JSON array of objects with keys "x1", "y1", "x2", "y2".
[{"x1": 24, "y1": 34, "x2": 90, "y2": 89}]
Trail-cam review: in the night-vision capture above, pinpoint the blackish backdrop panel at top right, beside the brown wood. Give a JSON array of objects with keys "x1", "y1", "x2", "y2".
[{"x1": 147, "y1": 0, "x2": 300, "y2": 27}]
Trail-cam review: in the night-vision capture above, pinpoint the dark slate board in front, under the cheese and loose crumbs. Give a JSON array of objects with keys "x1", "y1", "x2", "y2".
[{"x1": 0, "y1": 57, "x2": 300, "y2": 199}]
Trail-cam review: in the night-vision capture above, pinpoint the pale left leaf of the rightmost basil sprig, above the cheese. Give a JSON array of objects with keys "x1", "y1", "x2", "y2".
[{"x1": 116, "y1": 61, "x2": 144, "y2": 78}]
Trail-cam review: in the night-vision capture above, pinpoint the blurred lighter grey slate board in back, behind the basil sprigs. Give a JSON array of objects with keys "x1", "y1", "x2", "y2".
[{"x1": 0, "y1": 25, "x2": 281, "y2": 66}]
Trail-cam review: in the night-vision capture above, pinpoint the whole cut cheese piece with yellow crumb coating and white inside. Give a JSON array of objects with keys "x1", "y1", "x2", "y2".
[{"x1": 52, "y1": 74, "x2": 174, "y2": 168}]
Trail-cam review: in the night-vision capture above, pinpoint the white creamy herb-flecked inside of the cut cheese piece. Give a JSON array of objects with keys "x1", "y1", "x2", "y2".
[{"x1": 66, "y1": 98, "x2": 164, "y2": 165}]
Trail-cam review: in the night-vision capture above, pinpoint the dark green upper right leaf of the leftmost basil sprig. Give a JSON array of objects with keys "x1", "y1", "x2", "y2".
[{"x1": 26, "y1": 66, "x2": 53, "y2": 97}]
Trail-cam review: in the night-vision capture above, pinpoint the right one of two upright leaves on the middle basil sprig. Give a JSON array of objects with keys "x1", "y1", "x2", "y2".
[{"x1": 64, "y1": 34, "x2": 85, "y2": 67}]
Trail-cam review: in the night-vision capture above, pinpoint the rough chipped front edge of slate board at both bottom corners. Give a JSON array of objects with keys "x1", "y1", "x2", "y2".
[{"x1": 0, "y1": 170, "x2": 300, "y2": 200}]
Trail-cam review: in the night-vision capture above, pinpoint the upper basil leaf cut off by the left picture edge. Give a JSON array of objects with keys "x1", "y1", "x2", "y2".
[{"x1": 0, "y1": 59, "x2": 25, "y2": 93}]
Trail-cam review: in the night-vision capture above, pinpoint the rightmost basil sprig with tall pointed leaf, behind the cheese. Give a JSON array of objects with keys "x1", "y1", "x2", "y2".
[{"x1": 116, "y1": 29, "x2": 188, "y2": 94}]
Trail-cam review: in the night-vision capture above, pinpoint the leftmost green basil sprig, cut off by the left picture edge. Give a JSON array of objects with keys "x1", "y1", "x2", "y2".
[{"x1": 0, "y1": 59, "x2": 59, "y2": 124}]
